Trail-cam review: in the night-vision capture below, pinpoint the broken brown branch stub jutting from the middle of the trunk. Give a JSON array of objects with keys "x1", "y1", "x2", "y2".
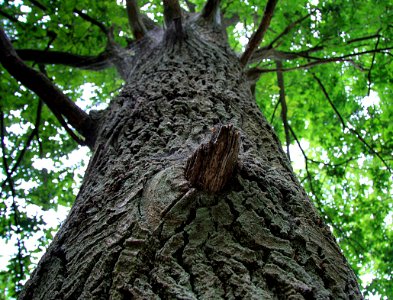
[{"x1": 185, "y1": 124, "x2": 240, "y2": 192}]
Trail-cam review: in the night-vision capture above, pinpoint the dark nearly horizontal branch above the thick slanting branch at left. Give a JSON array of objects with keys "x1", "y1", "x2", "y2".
[{"x1": 16, "y1": 49, "x2": 112, "y2": 71}]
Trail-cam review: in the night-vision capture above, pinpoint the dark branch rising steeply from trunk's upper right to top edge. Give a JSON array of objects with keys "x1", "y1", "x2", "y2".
[{"x1": 240, "y1": 0, "x2": 278, "y2": 66}]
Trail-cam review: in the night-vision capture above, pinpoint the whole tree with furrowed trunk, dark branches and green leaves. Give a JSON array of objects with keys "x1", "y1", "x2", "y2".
[{"x1": 0, "y1": 0, "x2": 392, "y2": 299}]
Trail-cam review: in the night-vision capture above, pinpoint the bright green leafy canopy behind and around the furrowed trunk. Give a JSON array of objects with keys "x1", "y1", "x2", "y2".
[{"x1": 0, "y1": 1, "x2": 393, "y2": 297}]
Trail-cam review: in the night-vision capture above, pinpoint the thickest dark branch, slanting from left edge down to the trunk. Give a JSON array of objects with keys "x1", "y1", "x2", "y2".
[{"x1": 0, "y1": 28, "x2": 95, "y2": 146}]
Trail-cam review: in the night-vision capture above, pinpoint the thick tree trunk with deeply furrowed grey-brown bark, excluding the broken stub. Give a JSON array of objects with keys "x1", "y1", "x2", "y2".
[{"x1": 21, "y1": 18, "x2": 361, "y2": 299}]
